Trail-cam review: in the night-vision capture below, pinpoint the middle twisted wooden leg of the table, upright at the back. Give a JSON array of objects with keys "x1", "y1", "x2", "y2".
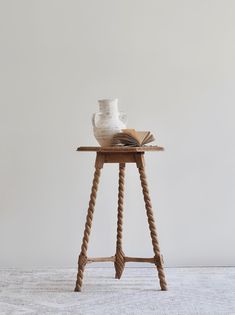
[{"x1": 114, "y1": 163, "x2": 125, "y2": 279}]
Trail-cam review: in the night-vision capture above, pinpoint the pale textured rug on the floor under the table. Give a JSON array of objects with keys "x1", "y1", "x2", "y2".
[{"x1": 0, "y1": 267, "x2": 235, "y2": 315}]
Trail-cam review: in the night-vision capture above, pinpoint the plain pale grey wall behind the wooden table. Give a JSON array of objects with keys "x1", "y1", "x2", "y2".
[{"x1": 0, "y1": 0, "x2": 235, "y2": 266}]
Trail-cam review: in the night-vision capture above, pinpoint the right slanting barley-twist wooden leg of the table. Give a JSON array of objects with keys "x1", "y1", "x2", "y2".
[{"x1": 138, "y1": 166, "x2": 167, "y2": 291}]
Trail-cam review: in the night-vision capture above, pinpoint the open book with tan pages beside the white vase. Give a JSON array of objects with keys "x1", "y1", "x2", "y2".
[{"x1": 112, "y1": 129, "x2": 155, "y2": 147}]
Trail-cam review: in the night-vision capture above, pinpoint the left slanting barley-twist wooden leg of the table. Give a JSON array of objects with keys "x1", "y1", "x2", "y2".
[{"x1": 74, "y1": 167, "x2": 100, "y2": 292}]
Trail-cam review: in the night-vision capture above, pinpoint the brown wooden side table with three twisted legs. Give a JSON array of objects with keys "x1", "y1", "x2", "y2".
[{"x1": 75, "y1": 146, "x2": 167, "y2": 291}]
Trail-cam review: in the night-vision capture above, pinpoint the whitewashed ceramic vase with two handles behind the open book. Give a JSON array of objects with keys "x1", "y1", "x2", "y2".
[{"x1": 92, "y1": 99, "x2": 127, "y2": 147}]
